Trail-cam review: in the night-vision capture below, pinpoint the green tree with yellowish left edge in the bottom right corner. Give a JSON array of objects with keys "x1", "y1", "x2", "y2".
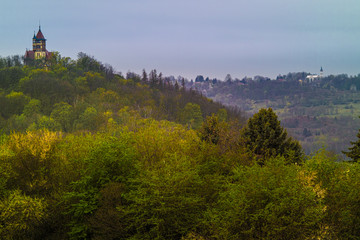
[{"x1": 305, "y1": 150, "x2": 360, "y2": 239}]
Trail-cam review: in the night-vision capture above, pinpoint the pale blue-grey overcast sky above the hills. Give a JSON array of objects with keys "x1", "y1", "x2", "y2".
[{"x1": 0, "y1": 0, "x2": 360, "y2": 79}]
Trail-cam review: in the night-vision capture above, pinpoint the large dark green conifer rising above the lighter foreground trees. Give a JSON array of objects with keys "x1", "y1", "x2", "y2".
[{"x1": 243, "y1": 108, "x2": 303, "y2": 164}]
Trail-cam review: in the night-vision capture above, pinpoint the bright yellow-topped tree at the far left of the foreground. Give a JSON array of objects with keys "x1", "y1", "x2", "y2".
[{"x1": 4, "y1": 130, "x2": 62, "y2": 195}]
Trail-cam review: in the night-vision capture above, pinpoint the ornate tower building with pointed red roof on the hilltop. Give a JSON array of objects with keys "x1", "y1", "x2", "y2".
[{"x1": 25, "y1": 25, "x2": 52, "y2": 64}]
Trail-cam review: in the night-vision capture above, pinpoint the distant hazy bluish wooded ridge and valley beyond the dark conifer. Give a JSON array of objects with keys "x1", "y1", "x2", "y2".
[{"x1": 193, "y1": 72, "x2": 360, "y2": 157}]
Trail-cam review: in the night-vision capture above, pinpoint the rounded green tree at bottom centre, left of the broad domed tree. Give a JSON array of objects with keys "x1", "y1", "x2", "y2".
[{"x1": 125, "y1": 154, "x2": 206, "y2": 239}]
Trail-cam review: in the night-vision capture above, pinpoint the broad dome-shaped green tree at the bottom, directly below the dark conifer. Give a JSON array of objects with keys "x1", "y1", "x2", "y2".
[{"x1": 208, "y1": 157, "x2": 325, "y2": 240}]
